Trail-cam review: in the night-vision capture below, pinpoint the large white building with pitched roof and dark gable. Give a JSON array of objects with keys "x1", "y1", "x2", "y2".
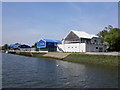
[{"x1": 58, "y1": 30, "x2": 106, "y2": 52}]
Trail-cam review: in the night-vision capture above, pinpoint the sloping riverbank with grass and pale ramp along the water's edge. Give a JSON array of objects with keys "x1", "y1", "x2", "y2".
[{"x1": 7, "y1": 52, "x2": 120, "y2": 67}]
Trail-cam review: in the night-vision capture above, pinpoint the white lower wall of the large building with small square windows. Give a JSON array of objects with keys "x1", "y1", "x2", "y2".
[{"x1": 57, "y1": 43, "x2": 106, "y2": 52}]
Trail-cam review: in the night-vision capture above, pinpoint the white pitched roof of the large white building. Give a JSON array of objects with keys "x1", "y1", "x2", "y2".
[{"x1": 71, "y1": 30, "x2": 98, "y2": 39}]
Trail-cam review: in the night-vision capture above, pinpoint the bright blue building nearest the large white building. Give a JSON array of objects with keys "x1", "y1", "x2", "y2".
[{"x1": 37, "y1": 39, "x2": 62, "y2": 51}]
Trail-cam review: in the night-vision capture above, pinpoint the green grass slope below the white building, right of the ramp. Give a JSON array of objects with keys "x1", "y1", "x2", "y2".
[{"x1": 63, "y1": 54, "x2": 120, "y2": 66}]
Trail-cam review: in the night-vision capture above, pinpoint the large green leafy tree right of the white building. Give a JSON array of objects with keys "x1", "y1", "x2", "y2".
[{"x1": 98, "y1": 25, "x2": 120, "y2": 51}]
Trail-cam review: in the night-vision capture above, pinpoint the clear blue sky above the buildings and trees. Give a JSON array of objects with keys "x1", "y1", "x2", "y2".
[{"x1": 2, "y1": 2, "x2": 118, "y2": 45}]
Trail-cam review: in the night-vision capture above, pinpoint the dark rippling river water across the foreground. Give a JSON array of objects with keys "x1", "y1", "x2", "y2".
[{"x1": 2, "y1": 53, "x2": 118, "y2": 88}]
